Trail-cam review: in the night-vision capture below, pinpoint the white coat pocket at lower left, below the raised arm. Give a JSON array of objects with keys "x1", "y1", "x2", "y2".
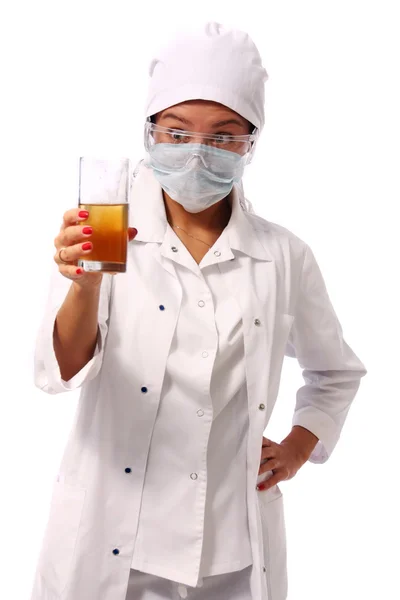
[{"x1": 38, "y1": 481, "x2": 86, "y2": 595}]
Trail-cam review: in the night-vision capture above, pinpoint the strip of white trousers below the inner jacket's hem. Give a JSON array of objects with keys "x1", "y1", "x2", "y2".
[{"x1": 125, "y1": 565, "x2": 252, "y2": 600}]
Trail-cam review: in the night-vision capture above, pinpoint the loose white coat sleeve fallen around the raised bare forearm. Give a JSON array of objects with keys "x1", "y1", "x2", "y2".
[{"x1": 34, "y1": 265, "x2": 112, "y2": 394}]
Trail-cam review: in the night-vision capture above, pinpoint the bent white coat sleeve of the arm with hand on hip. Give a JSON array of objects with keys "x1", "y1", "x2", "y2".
[{"x1": 286, "y1": 246, "x2": 367, "y2": 463}]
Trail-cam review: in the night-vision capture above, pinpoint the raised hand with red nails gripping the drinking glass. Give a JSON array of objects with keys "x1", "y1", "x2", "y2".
[{"x1": 54, "y1": 208, "x2": 137, "y2": 287}]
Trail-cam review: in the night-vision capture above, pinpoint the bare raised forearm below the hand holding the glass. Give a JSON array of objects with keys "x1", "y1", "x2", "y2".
[{"x1": 53, "y1": 283, "x2": 100, "y2": 381}]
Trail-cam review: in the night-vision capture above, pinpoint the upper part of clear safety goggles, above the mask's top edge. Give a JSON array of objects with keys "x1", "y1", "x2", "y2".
[{"x1": 144, "y1": 121, "x2": 258, "y2": 163}]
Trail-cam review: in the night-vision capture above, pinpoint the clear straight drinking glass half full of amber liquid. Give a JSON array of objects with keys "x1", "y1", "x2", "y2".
[{"x1": 78, "y1": 157, "x2": 130, "y2": 273}]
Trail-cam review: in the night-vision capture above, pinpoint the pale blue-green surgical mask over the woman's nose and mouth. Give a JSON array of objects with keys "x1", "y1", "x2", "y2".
[{"x1": 147, "y1": 143, "x2": 248, "y2": 213}]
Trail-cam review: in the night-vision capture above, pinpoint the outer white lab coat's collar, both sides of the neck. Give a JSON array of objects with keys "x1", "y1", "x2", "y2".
[{"x1": 129, "y1": 163, "x2": 272, "y2": 260}]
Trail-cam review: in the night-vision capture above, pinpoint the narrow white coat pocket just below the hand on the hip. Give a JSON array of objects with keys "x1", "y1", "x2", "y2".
[{"x1": 258, "y1": 485, "x2": 288, "y2": 600}]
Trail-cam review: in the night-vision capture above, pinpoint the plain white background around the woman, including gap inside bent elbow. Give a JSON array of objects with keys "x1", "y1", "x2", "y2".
[{"x1": 0, "y1": 0, "x2": 400, "y2": 600}]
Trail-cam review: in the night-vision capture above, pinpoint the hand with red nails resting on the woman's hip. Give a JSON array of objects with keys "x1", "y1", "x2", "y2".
[{"x1": 257, "y1": 437, "x2": 308, "y2": 491}]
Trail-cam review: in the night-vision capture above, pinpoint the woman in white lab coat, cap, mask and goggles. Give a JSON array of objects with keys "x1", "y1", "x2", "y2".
[{"x1": 32, "y1": 23, "x2": 366, "y2": 600}]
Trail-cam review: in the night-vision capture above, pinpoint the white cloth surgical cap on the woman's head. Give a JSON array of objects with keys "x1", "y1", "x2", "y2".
[{"x1": 145, "y1": 23, "x2": 268, "y2": 131}]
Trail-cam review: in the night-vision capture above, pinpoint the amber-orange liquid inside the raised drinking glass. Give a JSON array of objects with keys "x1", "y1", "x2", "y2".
[{"x1": 79, "y1": 203, "x2": 129, "y2": 264}]
